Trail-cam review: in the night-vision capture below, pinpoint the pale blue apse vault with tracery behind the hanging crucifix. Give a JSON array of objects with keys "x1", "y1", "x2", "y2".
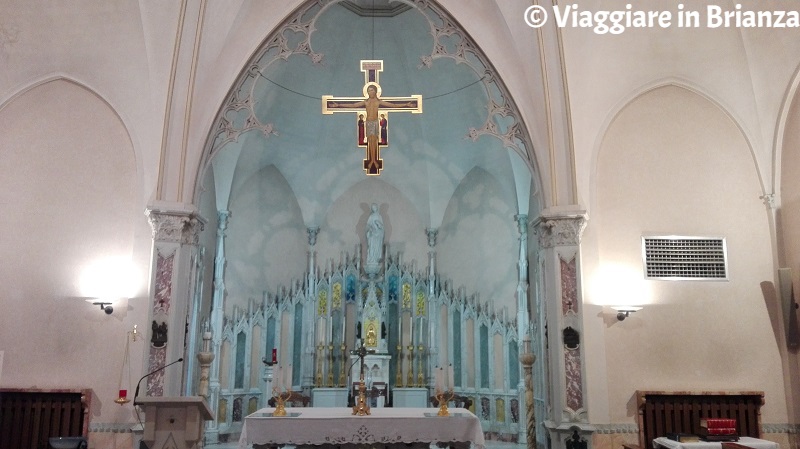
[{"x1": 200, "y1": 0, "x2": 534, "y2": 227}]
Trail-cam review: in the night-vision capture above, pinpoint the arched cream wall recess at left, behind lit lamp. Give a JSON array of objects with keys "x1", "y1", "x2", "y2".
[{"x1": 0, "y1": 80, "x2": 149, "y2": 422}]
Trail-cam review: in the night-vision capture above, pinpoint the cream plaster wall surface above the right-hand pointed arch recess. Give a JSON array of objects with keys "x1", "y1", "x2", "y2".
[{"x1": 562, "y1": 0, "x2": 800, "y2": 213}]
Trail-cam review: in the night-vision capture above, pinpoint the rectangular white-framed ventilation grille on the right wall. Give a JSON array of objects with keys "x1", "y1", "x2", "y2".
[{"x1": 642, "y1": 236, "x2": 728, "y2": 280}]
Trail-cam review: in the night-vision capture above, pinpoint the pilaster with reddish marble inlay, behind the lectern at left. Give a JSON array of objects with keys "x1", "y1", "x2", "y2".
[{"x1": 145, "y1": 207, "x2": 204, "y2": 396}]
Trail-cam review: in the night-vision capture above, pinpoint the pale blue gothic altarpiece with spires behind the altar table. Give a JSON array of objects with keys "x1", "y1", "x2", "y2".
[{"x1": 207, "y1": 207, "x2": 525, "y2": 441}]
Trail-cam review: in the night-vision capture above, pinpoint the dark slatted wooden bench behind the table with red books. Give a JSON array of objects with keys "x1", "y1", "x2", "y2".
[{"x1": 623, "y1": 390, "x2": 764, "y2": 449}]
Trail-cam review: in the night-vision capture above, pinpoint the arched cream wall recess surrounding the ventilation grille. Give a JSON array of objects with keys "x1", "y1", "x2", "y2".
[{"x1": 583, "y1": 86, "x2": 787, "y2": 423}]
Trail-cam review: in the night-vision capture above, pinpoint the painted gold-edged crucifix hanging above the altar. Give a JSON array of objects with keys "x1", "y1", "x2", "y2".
[{"x1": 322, "y1": 60, "x2": 422, "y2": 176}]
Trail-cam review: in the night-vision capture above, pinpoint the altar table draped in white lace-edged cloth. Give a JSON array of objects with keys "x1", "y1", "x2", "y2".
[{"x1": 239, "y1": 407, "x2": 485, "y2": 449}]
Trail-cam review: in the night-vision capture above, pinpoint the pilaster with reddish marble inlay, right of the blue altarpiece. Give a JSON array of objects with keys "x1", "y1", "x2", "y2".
[{"x1": 533, "y1": 211, "x2": 595, "y2": 447}]
